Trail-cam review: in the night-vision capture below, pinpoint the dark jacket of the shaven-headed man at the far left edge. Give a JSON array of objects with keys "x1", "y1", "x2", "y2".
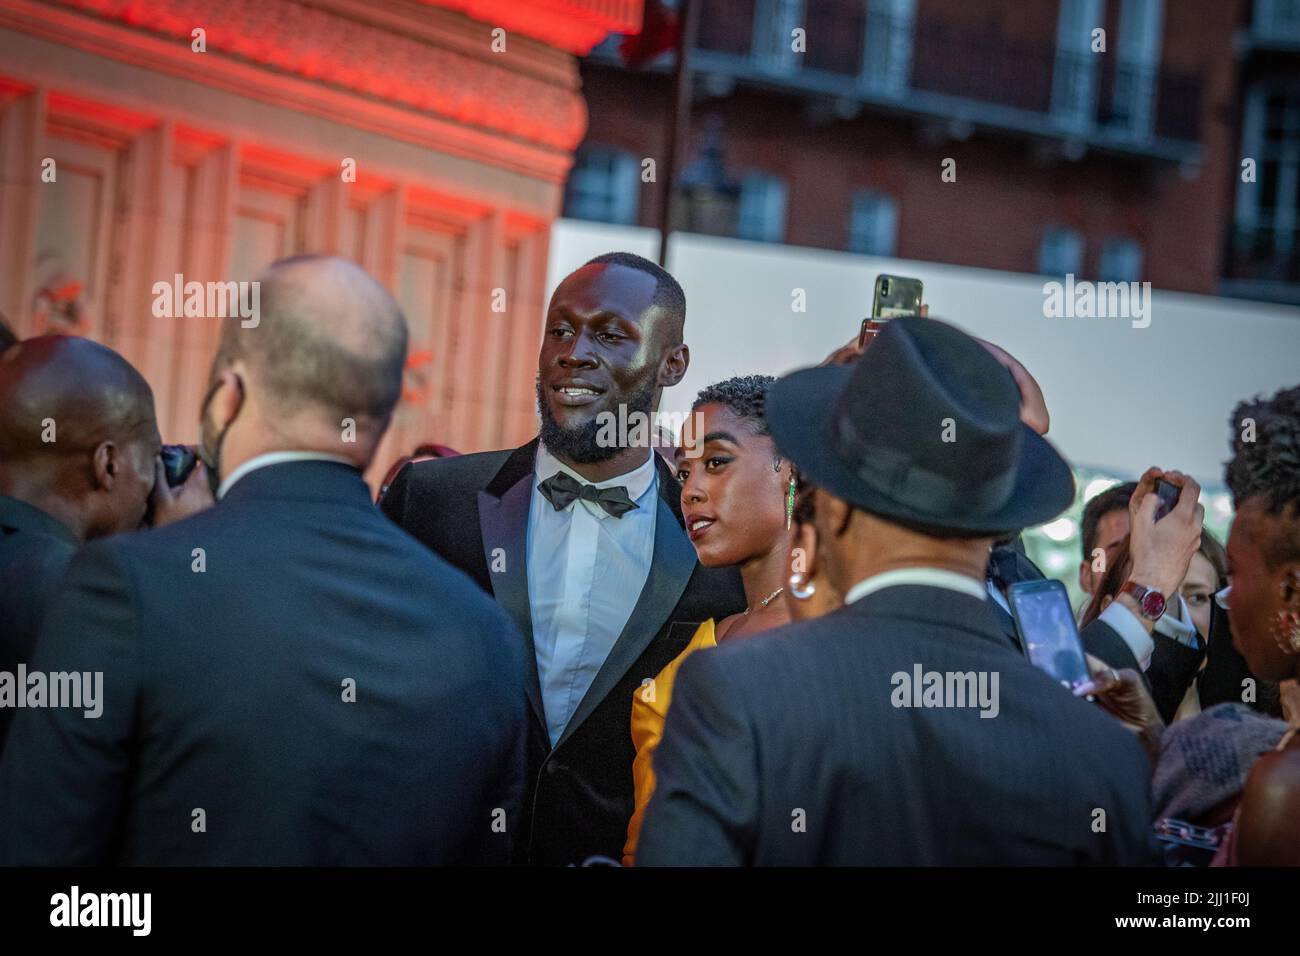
[{"x1": 0, "y1": 494, "x2": 78, "y2": 752}]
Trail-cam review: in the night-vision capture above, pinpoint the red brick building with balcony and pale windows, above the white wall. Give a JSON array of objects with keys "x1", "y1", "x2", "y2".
[{"x1": 566, "y1": 0, "x2": 1300, "y2": 299}]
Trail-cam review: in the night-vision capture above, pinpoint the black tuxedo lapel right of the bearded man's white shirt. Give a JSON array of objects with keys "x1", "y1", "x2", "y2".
[{"x1": 555, "y1": 453, "x2": 696, "y2": 748}]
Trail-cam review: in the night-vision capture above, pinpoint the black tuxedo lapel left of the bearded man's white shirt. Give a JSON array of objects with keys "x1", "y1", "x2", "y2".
[{"x1": 478, "y1": 442, "x2": 546, "y2": 727}]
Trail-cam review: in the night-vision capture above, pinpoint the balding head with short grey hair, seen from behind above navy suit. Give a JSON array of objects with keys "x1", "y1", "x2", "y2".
[{"x1": 213, "y1": 255, "x2": 407, "y2": 428}]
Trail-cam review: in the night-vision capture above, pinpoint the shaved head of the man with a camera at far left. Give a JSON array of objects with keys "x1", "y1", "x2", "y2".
[{"x1": 0, "y1": 336, "x2": 160, "y2": 537}]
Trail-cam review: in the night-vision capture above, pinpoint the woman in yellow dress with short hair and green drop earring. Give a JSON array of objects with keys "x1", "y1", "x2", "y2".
[{"x1": 623, "y1": 375, "x2": 836, "y2": 866}]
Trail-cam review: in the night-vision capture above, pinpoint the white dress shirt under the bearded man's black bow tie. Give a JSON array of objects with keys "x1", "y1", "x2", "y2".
[{"x1": 528, "y1": 444, "x2": 659, "y2": 747}]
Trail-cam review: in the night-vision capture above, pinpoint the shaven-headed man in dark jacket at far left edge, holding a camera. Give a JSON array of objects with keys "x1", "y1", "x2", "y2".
[{"x1": 0, "y1": 336, "x2": 159, "y2": 749}]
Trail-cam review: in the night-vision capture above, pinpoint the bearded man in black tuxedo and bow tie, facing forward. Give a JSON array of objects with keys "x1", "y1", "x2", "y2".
[{"x1": 382, "y1": 252, "x2": 745, "y2": 865}]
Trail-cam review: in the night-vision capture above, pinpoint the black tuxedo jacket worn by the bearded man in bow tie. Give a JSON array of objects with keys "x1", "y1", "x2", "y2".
[{"x1": 384, "y1": 438, "x2": 745, "y2": 865}]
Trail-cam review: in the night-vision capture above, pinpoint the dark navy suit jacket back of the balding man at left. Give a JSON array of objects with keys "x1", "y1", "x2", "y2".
[{"x1": 0, "y1": 462, "x2": 525, "y2": 865}]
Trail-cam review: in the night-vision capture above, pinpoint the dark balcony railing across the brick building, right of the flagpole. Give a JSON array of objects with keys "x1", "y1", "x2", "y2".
[{"x1": 699, "y1": 0, "x2": 1196, "y2": 150}]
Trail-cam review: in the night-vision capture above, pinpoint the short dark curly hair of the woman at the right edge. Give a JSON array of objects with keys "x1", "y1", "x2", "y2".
[{"x1": 1227, "y1": 385, "x2": 1300, "y2": 566}]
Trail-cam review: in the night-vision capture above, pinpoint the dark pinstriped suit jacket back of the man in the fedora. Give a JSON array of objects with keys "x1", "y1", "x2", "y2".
[{"x1": 637, "y1": 585, "x2": 1153, "y2": 866}]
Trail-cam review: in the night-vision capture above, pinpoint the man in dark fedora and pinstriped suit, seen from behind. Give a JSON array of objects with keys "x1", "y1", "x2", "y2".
[{"x1": 637, "y1": 319, "x2": 1152, "y2": 865}]
